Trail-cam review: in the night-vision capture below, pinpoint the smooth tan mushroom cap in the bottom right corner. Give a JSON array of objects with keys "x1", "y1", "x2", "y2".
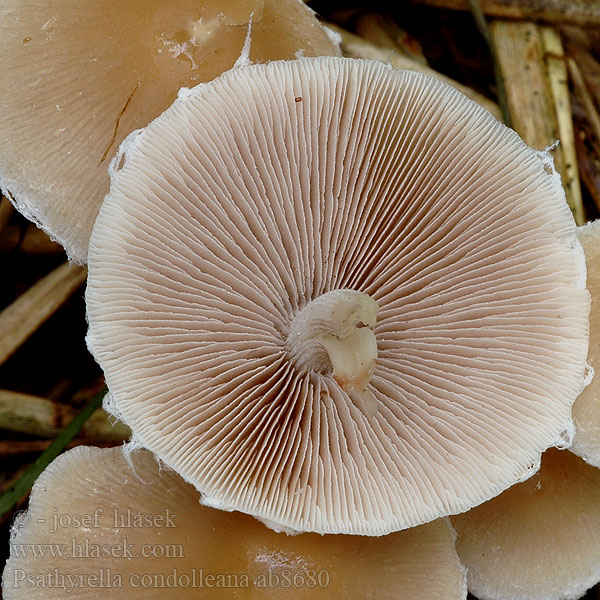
[{"x1": 452, "y1": 450, "x2": 600, "y2": 600}]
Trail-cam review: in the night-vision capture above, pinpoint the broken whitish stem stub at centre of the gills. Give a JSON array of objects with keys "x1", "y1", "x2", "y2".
[{"x1": 287, "y1": 290, "x2": 378, "y2": 392}]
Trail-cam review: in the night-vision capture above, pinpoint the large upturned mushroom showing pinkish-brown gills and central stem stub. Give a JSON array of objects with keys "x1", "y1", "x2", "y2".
[{"x1": 87, "y1": 58, "x2": 589, "y2": 535}]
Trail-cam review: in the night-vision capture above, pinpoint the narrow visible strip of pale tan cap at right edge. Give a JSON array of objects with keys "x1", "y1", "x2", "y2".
[{"x1": 570, "y1": 220, "x2": 600, "y2": 467}]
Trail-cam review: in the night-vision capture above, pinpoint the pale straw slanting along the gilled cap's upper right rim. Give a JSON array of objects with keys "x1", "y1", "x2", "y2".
[{"x1": 326, "y1": 23, "x2": 502, "y2": 119}]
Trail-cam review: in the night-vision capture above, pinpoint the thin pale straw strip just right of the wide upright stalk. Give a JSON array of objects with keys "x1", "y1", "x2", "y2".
[{"x1": 540, "y1": 27, "x2": 586, "y2": 225}]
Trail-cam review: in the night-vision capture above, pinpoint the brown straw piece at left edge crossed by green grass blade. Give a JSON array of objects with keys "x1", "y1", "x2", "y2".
[{"x1": 0, "y1": 390, "x2": 131, "y2": 442}]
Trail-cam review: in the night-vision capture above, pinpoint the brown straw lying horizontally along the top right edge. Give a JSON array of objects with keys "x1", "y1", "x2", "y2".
[{"x1": 411, "y1": 0, "x2": 600, "y2": 27}]
